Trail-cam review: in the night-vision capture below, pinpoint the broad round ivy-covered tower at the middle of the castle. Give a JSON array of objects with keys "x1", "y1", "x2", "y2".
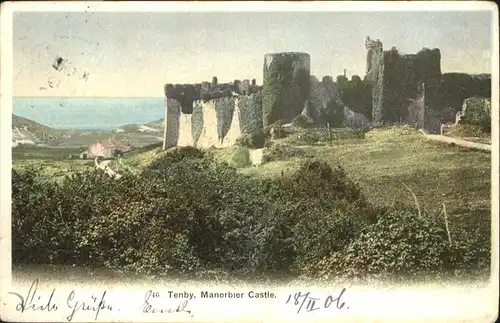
[{"x1": 262, "y1": 52, "x2": 311, "y2": 126}]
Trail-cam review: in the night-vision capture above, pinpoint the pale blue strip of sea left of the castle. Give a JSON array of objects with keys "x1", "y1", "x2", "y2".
[{"x1": 12, "y1": 97, "x2": 164, "y2": 131}]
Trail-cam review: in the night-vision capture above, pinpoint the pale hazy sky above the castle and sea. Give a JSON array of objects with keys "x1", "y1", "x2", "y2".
[{"x1": 13, "y1": 11, "x2": 493, "y2": 97}]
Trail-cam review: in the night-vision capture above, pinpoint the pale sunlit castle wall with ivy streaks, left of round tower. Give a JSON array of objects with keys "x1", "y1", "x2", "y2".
[{"x1": 164, "y1": 79, "x2": 263, "y2": 148}]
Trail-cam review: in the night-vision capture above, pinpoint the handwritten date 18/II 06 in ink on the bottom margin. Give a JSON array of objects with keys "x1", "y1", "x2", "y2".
[{"x1": 286, "y1": 288, "x2": 349, "y2": 313}]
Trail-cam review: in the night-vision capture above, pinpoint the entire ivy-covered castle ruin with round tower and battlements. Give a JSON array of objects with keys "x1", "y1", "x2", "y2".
[{"x1": 163, "y1": 37, "x2": 491, "y2": 149}]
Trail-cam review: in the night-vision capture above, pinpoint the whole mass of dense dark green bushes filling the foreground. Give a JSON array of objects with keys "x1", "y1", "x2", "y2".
[{"x1": 12, "y1": 146, "x2": 490, "y2": 284}]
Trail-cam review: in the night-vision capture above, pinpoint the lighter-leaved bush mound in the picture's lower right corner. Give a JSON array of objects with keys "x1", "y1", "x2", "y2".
[{"x1": 306, "y1": 207, "x2": 490, "y2": 281}]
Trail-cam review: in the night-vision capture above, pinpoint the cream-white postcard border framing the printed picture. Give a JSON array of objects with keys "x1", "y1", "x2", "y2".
[{"x1": 0, "y1": 1, "x2": 500, "y2": 322}]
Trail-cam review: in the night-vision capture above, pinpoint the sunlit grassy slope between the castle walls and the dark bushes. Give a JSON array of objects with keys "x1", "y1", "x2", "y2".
[{"x1": 116, "y1": 127, "x2": 491, "y2": 216}]
